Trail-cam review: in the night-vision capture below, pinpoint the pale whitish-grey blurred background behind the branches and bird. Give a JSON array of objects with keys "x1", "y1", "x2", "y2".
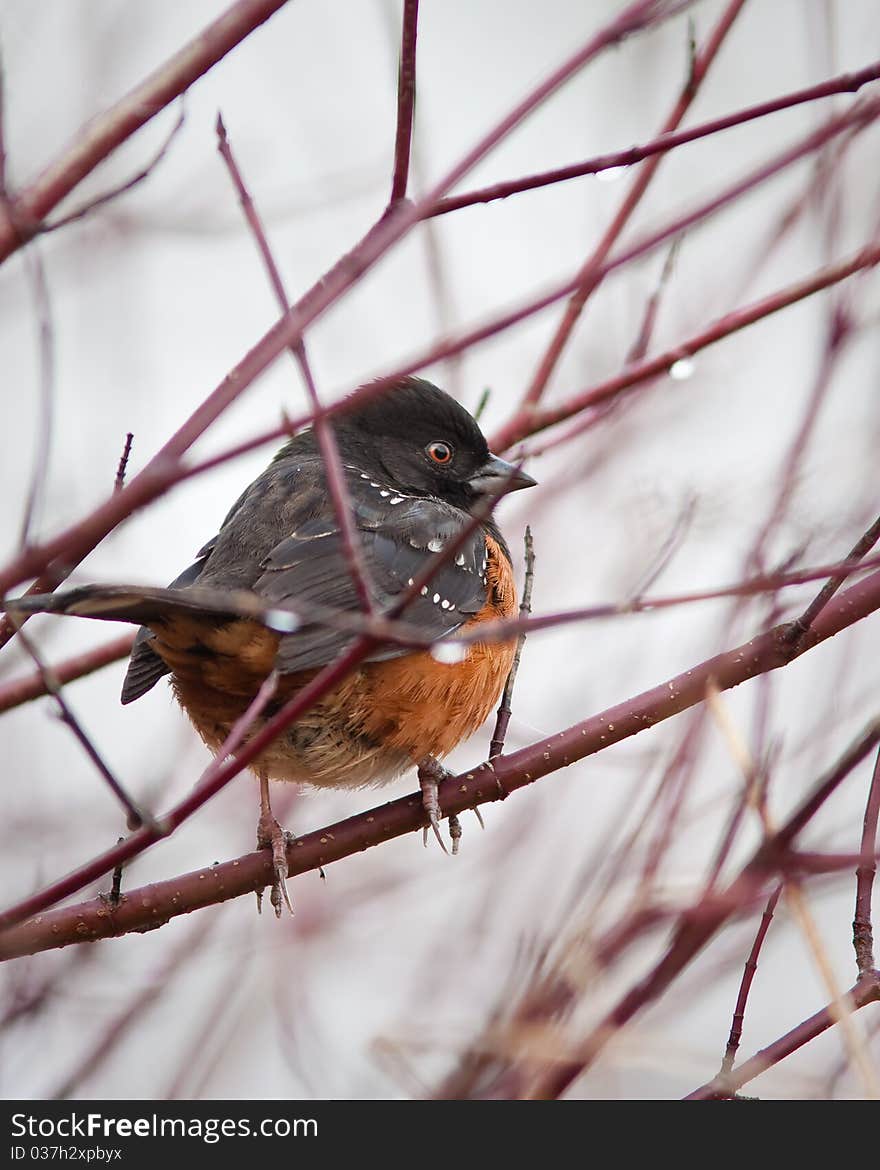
[{"x1": 0, "y1": 0, "x2": 880, "y2": 1099}]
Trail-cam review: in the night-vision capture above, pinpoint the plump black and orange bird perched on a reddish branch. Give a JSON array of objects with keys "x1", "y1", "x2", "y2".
[{"x1": 7, "y1": 377, "x2": 536, "y2": 916}]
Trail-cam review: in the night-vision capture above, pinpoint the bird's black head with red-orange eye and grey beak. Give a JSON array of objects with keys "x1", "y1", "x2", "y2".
[{"x1": 315, "y1": 378, "x2": 535, "y2": 510}]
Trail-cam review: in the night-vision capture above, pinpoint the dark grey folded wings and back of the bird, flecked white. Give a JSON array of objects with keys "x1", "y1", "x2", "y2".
[{"x1": 122, "y1": 454, "x2": 486, "y2": 703}]
